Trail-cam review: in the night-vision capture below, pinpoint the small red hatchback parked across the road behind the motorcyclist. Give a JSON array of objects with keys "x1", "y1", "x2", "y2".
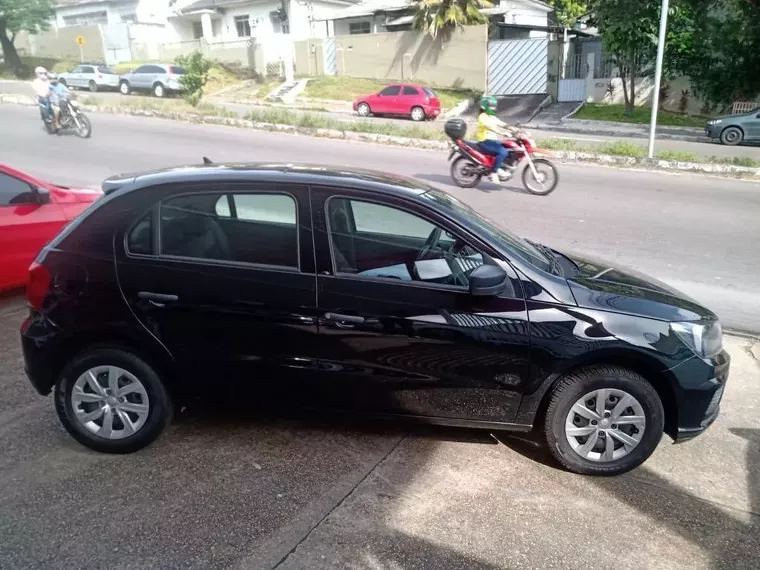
[{"x1": 354, "y1": 83, "x2": 441, "y2": 121}]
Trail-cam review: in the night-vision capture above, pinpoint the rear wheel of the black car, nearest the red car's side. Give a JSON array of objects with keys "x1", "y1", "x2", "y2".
[{"x1": 55, "y1": 347, "x2": 173, "y2": 453}]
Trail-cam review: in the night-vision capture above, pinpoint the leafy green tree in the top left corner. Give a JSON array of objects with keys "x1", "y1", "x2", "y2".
[{"x1": 0, "y1": 0, "x2": 55, "y2": 75}]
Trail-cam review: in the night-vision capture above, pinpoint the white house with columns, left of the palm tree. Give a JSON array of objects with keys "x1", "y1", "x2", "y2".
[{"x1": 169, "y1": 0, "x2": 356, "y2": 43}]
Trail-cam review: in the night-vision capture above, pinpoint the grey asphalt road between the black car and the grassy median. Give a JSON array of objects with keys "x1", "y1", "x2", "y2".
[{"x1": 0, "y1": 105, "x2": 760, "y2": 332}]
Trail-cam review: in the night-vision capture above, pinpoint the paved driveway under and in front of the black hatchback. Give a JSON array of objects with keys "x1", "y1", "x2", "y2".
[{"x1": 0, "y1": 290, "x2": 760, "y2": 570}]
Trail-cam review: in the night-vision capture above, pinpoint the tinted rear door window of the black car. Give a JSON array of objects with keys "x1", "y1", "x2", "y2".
[{"x1": 161, "y1": 194, "x2": 299, "y2": 268}]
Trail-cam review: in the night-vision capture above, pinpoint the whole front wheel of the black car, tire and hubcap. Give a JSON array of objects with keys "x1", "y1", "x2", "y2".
[{"x1": 544, "y1": 366, "x2": 665, "y2": 476}]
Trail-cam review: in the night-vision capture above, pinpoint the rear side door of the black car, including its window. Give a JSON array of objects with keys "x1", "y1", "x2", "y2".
[{"x1": 116, "y1": 183, "x2": 317, "y2": 397}]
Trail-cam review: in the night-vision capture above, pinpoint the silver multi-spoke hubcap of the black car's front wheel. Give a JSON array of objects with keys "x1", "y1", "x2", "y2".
[{"x1": 565, "y1": 388, "x2": 646, "y2": 463}]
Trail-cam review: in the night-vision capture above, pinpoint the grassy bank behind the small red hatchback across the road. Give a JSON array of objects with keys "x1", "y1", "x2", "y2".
[{"x1": 303, "y1": 75, "x2": 476, "y2": 109}]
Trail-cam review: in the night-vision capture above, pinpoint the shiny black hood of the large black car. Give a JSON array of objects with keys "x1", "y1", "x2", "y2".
[{"x1": 563, "y1": 254, "x2": 717, "y2": 322}]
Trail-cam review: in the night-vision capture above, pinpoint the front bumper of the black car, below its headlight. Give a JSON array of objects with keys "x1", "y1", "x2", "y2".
[{"x1": 671, "y1": 351, "x2": 731, "y2": 443}]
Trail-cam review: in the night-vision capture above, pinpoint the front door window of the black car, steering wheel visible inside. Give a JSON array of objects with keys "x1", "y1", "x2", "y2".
[{"x1": 327, "y1": 198, "x2": 484, "y2": 288}]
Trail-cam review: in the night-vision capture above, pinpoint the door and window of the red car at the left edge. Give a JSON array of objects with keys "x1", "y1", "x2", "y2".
[{"x1": 0, "y1": 172, "x2": 66, "y2": 289}]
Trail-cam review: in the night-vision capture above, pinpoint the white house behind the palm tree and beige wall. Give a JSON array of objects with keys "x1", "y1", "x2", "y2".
[{"x1": 320, "y1": 0, "x2": 554, "y2": 39}]
